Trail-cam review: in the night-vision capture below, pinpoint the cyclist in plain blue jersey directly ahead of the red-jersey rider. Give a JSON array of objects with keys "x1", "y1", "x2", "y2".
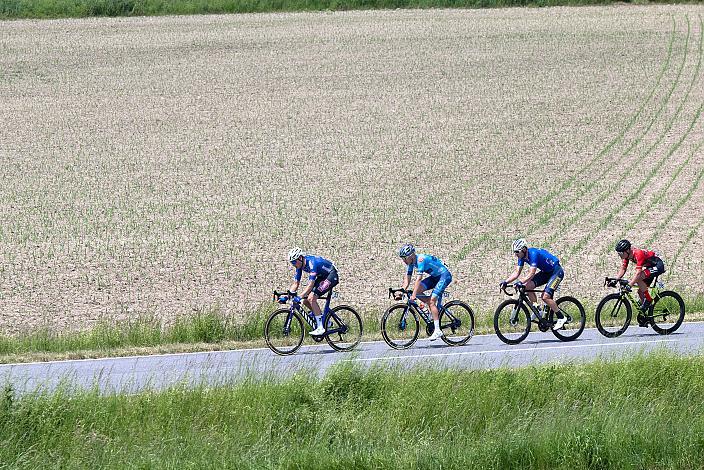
[{"x1": 499, "y1": 238, "x2": 567, "y2": 330}]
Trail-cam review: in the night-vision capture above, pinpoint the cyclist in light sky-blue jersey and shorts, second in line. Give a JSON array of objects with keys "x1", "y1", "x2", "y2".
[{"x1": 396, "y1": 243, "x2": 452, "y2": 341}]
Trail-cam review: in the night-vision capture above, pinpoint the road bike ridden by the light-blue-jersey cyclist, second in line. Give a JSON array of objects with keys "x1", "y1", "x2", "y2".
[{"x1": 381, "y1": 288, "x2": 474, "y2": 349}]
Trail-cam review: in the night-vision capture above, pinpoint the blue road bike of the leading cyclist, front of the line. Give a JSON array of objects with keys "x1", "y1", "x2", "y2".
[{"x1": 264, "y1": 290, "x2": 362, "y2": 356}]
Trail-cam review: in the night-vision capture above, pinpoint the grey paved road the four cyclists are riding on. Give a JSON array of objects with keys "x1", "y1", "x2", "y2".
[{"x1": 0, "y1": 323, "x2": 704, "y2": 393}]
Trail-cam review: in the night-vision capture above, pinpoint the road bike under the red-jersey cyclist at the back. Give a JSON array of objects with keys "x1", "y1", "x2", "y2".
[{"x1": 594, "y1": 277, "x2": 685, "y2": 338}]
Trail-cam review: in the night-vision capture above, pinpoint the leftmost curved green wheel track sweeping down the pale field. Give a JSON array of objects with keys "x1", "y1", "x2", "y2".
[{"x1": 455, "y1": 15, "x2": 679, "y2": 261}]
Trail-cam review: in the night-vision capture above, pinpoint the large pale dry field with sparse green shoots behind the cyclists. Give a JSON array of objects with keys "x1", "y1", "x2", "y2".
[{"x1": 0, "y1": 6, "x2": 704, "y2": 332}]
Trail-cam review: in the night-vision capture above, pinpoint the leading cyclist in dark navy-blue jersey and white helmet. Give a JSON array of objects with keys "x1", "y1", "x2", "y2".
[{"x1": 280, "y1": 247, "x2": 340, "y2": 336}]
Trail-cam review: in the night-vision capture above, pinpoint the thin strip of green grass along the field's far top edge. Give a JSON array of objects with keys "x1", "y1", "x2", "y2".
[{"x1": 0, "y1": 0, "x2": 691, "y2": 19}]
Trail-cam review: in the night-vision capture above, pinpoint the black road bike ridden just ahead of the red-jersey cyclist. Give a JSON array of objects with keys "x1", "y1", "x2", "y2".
[{"x1": 494, "y1": 284, "x2": 586, "y2": 344}]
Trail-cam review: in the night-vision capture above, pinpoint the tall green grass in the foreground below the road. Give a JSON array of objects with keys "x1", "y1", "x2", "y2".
[{"x1": 0, "y1": 354, "x2": 704, "y2": 470}]
